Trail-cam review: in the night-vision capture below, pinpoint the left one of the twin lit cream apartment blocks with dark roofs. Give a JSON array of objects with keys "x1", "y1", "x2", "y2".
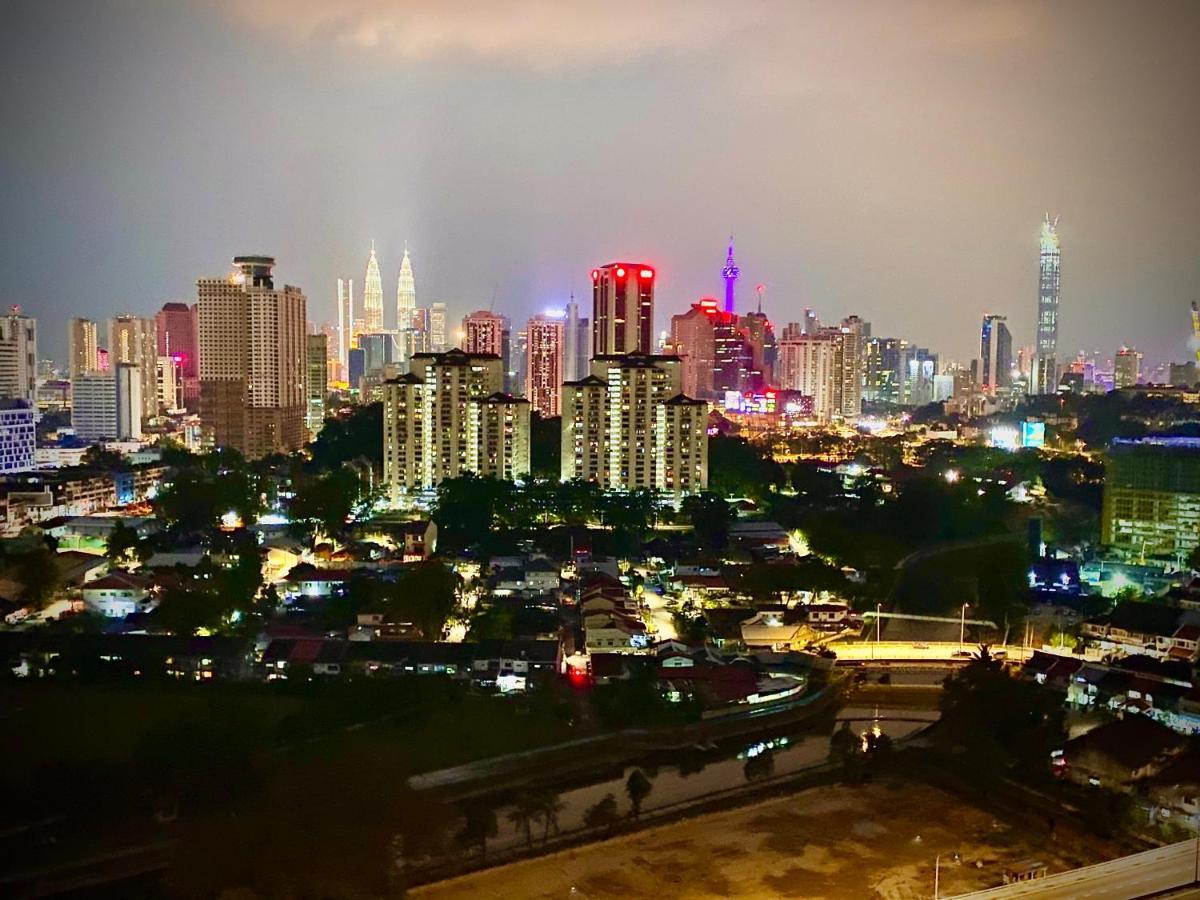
[{"x1": 383, "y1": 349, "x2": 520, "y2": 502}]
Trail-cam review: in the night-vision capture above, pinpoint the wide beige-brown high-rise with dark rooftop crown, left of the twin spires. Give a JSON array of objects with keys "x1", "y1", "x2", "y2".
[{"x1": 197, "y1": 256, "x2": 307, "y2": 458}]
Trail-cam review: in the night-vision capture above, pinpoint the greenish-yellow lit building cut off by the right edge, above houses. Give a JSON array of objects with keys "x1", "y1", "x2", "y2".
[{"x1": 1100, "y1": 437, "x2": 1200, "y2": 565}]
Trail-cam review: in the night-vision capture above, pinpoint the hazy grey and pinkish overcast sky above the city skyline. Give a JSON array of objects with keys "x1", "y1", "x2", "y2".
[{"x1": 0, "y1": 0, "x2": 1200, "y2": 360}]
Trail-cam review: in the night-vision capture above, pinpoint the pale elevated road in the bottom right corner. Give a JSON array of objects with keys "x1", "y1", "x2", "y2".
[{"x1": 959, "y1": 840, "x2": 1200, "y2": 900}]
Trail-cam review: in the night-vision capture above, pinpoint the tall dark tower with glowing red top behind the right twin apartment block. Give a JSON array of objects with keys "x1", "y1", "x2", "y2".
[{"x1": 592, "y1": 263, "x2": 654, "y2": 356}]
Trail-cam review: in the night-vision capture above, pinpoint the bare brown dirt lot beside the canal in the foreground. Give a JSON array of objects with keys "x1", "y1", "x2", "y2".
[{"x1": 412, "y1": 782, "x2": 1121, "y2": 900}]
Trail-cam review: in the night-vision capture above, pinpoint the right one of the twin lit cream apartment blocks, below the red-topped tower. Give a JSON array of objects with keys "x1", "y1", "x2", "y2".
[{"x1": 562, "y1": 353, "x2": 708, "y2": 500}]
